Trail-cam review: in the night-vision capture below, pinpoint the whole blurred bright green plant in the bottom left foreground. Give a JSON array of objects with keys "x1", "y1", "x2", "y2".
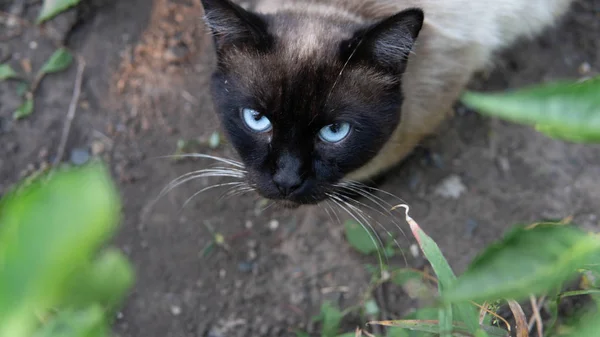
[{"x1": 0, "y1": 164, "x2": 134, "y2": 337}]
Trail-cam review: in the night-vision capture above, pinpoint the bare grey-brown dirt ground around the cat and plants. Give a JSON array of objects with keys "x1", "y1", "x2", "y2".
[{"x1": 0, "y1": 0, "x2": 600, "y2": 337}]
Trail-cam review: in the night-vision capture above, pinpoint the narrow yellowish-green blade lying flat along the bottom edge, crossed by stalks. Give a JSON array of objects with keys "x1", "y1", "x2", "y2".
[{"x1": 369, "y1": 320, "x2": 509, "y2": 337}]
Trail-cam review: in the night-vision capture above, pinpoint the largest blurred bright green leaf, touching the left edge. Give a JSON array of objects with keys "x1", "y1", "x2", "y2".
[{"x1": 0, "y1": 164, "x2": 120, "y2": 337}]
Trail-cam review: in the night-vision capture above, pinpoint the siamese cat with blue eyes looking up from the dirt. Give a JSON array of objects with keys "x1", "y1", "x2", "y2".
[{"x1": 197, "y1": 0, "x2": 572, "y2": 207}]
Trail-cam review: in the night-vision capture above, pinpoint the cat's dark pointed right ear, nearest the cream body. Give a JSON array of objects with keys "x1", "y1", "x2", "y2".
[{"x1": 341, "y1": 8, "x2": 424, "y2": 73}]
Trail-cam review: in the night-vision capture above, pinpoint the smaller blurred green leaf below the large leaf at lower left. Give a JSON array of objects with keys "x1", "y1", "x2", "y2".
[{"x1": 64, "y1": 249, "x2": 134, "y2": 315}]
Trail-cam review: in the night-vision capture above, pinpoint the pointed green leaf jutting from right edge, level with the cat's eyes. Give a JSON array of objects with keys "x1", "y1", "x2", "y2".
[{"x1": 461, "y1": 76, "x2": 600, "y2": 142}]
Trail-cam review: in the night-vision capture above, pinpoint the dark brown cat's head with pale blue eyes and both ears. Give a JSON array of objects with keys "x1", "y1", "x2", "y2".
[{"x1": 203, "y1": 0, "x2": 423, "y2": 205}]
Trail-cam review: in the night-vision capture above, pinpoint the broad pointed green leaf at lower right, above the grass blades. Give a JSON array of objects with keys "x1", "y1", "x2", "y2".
[{"x1": 443, "y1": 224, "x2": 600, "y2": 302}]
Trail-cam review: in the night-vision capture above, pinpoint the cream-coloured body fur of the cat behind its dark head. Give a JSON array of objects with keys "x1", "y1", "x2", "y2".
[{"x1": 255, "y1": 0, "x2": 573, "y2": 180}]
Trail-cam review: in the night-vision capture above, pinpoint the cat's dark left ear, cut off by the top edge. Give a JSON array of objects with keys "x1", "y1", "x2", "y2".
[{"x1": 202, "y1": 0, "x2": 273, "y2": 51}]
